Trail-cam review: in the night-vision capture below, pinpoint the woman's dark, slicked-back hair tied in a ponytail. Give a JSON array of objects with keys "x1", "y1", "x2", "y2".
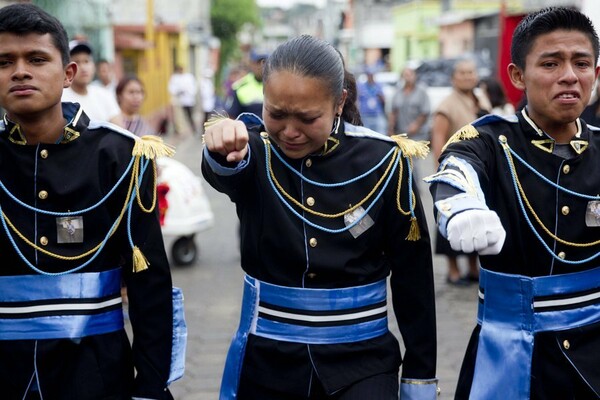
[{"x1": 263, "y1": 35, "x2": 362, "y2": 125}]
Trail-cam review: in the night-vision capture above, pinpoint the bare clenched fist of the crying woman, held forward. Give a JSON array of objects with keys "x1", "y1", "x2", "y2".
[{"x1": 203, "y1": 119, "x2": 248, "y2": 162}]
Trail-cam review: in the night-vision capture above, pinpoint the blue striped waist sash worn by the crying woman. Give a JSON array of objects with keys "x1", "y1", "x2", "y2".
[{"x1": 219, "y1": 275, "x2": 388, "y2": 400}]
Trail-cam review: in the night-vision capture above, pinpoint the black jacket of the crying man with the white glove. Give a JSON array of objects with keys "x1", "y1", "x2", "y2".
[{"x1": 431, "y1": 109, "x2": 600, "y2": 398}]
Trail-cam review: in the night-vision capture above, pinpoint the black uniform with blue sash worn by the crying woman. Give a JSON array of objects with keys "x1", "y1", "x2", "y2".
[{"x1": 202, "y1": 115, "x2": 437, "y2": 400}]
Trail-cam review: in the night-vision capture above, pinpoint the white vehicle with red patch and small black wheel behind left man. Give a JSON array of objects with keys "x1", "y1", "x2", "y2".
[{"x1": 157, "y1": 157, "x2": 214, "y2": 265}]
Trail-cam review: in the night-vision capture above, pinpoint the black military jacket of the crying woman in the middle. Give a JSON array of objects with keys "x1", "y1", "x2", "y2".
[{"x1": 202, "y1": 118, "x2": 436, "y2": 394}]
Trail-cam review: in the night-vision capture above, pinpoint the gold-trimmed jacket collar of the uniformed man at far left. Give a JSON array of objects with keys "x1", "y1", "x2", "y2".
[{"x1": 0, "y1": 103, "x2": 90, "y2": 145}]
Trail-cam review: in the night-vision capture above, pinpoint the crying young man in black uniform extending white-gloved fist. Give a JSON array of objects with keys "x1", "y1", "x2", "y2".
[{"x1": 428, "y1": 8, "x2": 600, "y2": 399}]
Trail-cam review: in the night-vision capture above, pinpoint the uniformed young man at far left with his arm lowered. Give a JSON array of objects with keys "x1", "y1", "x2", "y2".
[{"x1": 0, "y1": 4, "x2": 181, "y2": 400}]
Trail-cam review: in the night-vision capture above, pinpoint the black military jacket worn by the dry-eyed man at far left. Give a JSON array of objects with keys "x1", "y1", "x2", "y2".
[{"x1": 0, "y1": 103, "x2": 173, "y2": 400}]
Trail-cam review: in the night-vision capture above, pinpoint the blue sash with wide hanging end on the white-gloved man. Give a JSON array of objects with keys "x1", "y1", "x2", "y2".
[{"x1": 469, "y1": 267, "x2": 600, "y2": 400}]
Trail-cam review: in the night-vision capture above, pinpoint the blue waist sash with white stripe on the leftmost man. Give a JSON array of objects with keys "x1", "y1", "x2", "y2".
[{"x1": 0, "y1": 268, "x2": 123, "y2": 340}]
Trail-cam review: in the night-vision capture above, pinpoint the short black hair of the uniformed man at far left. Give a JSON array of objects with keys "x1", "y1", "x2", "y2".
[{"x1": 0, "y1": 3, "x2": 71, "y2": 66}]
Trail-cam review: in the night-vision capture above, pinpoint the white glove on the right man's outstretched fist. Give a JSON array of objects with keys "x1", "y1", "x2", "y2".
[{"x1": 446, "y1": 210, "x2": 506, "y2": 255}]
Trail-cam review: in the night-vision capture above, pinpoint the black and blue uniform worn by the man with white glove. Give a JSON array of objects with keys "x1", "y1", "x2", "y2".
[{"x1": 427, "y1": 109, "x2": 600, "y2": 399}]
